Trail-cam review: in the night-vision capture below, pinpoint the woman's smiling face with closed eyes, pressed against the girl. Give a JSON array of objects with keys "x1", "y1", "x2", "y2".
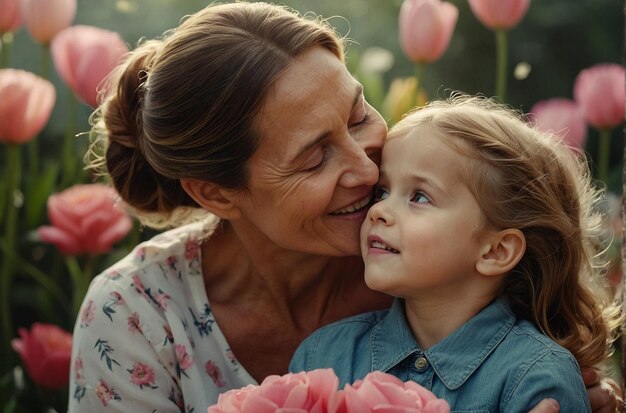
[{"x1": 227, "y1": 47, "x2": 387, "y2": 256}]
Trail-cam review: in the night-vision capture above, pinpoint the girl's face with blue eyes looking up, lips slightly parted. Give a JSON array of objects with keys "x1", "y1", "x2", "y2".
[{"x1": 361, "y1": 126, "x2": 487, "y2": 298}]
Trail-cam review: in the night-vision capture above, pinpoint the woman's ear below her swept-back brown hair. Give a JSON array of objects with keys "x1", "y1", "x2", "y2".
[{"x1": 180, "y1": 179, "x2": 241, "y2": 220}]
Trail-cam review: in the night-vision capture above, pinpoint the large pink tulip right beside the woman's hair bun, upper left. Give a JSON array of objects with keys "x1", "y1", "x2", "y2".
[{"x1": 51, "y1": 26, "x2": 128, "y2": 107}]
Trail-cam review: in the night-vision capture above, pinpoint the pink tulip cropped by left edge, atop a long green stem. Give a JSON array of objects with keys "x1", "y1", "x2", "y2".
[{"x1": 0, "y1": 69, "x2": 56, "y2": 143}]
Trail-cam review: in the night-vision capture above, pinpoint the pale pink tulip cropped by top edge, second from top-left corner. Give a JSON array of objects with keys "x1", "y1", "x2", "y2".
[{"x1": 21, "y1": 0, "x2": 76, "y2": 45}]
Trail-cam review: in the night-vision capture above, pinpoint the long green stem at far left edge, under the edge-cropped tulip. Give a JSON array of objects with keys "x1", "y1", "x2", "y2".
[{"x1": 0, "y1": 144, "x2": 22, "y2": 371}]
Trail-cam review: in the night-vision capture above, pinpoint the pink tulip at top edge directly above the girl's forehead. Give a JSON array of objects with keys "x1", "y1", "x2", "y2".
[{"x1": 399, "y1": 0, "x2": 459, "y2": 63}]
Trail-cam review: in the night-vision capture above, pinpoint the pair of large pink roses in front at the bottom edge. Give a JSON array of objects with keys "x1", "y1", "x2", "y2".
[{"x1": 208, "y1": 369, "x2": 450, "y2": 413}]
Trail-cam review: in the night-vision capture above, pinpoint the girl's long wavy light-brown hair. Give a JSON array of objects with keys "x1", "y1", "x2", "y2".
[{"x1": 389, "y1": 95, "x2": 619, "y2": 367}]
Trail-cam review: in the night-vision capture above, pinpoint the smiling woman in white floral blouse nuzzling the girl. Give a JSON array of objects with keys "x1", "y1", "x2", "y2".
[{"x1": 70, "y1": 3, "x2": 615, "y2": 412}]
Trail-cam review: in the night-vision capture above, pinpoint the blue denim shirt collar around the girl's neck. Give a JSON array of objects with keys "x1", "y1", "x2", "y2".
[{"x1": 370, "y1": 298, "x2": 515, "y2": 390}]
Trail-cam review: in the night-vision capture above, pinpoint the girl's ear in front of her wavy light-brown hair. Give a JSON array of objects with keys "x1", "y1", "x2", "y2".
[{"x1": 476, "y1": 228, "x2": 526, "y2": 276}]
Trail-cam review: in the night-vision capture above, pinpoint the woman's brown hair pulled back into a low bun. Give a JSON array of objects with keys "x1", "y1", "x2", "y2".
[{"x1": 91, "y1": 2, "x2": 343, "y2": 226}]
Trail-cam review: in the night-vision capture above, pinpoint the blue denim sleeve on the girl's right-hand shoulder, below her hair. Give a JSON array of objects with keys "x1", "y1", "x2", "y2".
[{"x1": 501, "y1": 351, "x2": 591, "y2": 413}]
